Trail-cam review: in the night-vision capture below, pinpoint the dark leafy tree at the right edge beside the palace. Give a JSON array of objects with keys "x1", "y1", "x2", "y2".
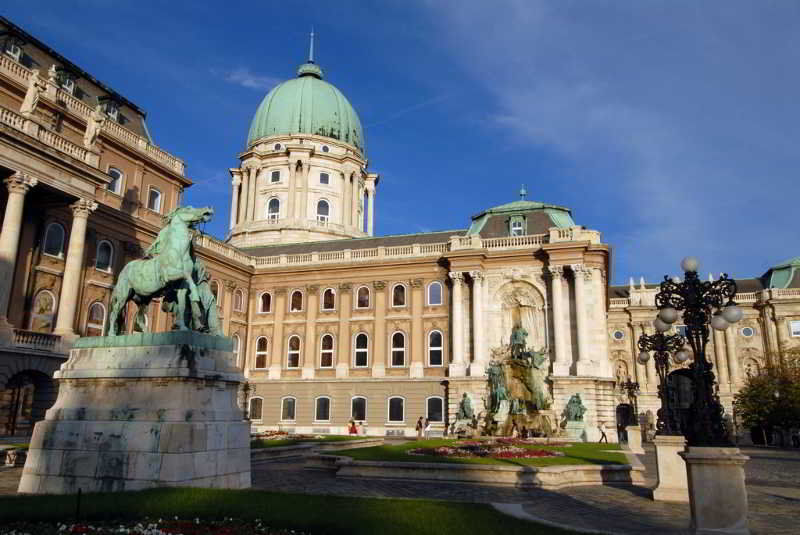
[{"x1": 733, "y1": 349, "x2": 800, "y2": 444}]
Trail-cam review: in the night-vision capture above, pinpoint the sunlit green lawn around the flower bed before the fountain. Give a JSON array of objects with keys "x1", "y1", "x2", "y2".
[{"x1": 330, "y1": 439, "x2": 628, "y2": 466}]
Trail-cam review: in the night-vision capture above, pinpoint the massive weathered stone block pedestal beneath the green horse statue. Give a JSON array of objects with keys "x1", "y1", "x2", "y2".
[{"x1": 19, "y1": 332, "x2": 250, "y2": 494}]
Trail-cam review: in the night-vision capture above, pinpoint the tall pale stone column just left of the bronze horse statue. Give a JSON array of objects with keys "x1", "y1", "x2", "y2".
[{"x1": 53, "y1": 199, "x2": 97, "y2": 338}]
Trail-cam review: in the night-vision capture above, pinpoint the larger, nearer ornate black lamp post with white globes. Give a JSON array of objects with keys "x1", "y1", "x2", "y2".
[{"x1": 654, "y1": 257, "x2": 742, "y2": 447}]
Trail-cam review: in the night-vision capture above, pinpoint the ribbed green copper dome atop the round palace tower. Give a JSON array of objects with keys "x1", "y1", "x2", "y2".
[{"x1": 247, "y1": 62, "x2": 365, "y2": 155}]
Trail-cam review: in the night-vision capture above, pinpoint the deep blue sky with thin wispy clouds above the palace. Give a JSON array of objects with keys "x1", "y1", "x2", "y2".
[{"x1": 7, "y1": 0, "x2": 800, "y2": 283}]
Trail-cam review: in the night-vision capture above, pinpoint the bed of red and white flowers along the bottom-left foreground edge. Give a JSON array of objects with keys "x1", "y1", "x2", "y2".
[{"x1": 0, "y1": 517, "x2": 306, "y2": 535}]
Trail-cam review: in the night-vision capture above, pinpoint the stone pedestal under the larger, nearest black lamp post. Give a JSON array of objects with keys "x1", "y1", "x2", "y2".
[{"x1": 680, "y1": 446, "x2": 750, "y2": 535}]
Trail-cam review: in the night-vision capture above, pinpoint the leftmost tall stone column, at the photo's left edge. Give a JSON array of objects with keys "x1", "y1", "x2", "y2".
[{"x1": 0, "y1": 173, "x2": 38, "y2": 326}]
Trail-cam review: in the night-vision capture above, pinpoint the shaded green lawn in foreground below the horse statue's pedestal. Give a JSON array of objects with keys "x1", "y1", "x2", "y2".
[{"x1": 0, "y1": 488, "x2": 571, "y2": 535}]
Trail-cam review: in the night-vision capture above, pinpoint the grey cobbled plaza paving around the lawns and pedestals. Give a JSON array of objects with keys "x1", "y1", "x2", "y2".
[{"x1": 0, "y1": 446, "x2": 800, "y2": 534}]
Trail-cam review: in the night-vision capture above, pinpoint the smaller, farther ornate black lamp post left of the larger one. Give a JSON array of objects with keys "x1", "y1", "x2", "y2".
[{"x1": 637, "y1": 330, "x2": 689, "y2": 435}]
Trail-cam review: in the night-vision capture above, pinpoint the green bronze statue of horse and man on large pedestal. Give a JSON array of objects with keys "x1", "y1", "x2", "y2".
[{"x1": 108, "y1": 206, "x2": 221, "y2": 336}]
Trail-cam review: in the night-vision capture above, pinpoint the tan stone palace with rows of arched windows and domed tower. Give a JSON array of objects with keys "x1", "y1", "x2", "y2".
[{"x1": 0, "y1": 18, "x2": 800, "y2": 440}]
